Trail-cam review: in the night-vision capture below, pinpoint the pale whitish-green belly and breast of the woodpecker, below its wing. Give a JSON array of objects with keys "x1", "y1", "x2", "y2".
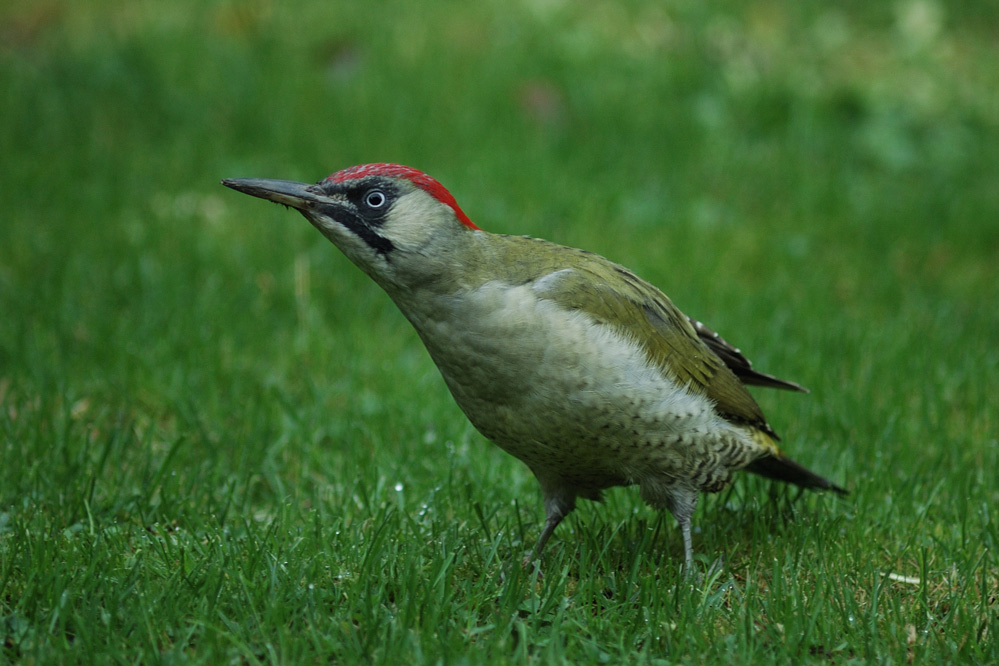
[{"x1": 402, "y1": 284, "x2": 748, "y2": 489}]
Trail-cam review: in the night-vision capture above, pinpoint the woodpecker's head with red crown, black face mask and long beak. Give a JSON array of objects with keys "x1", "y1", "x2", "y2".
[{"x1": 222, "y1": 164, "x2": 478, "y2": 288}]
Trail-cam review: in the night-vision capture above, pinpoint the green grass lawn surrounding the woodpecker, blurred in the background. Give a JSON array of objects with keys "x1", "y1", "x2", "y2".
[{"x1": 0, "y1": 0, "x2": 999, "y2": 664}]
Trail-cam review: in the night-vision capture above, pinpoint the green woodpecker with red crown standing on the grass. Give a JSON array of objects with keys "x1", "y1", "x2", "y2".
[{"x1": 222, "y1": 163, "x2": 846, "y2": 572}]
